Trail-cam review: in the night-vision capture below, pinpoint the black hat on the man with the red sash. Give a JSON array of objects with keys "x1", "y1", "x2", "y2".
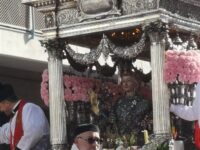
[{"x1": 0, "y1": 83, "x2": 16, "y2": 102}]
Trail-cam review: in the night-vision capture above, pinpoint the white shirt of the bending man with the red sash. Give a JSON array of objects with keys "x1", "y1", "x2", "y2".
[{"x1": 0, "y1": 103, "x2": 49, "y2": 150}]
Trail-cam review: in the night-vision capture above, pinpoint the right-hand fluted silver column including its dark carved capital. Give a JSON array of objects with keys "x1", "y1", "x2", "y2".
[{"x1": 148, "y1": 22, "x2": 170, "y2": 136}]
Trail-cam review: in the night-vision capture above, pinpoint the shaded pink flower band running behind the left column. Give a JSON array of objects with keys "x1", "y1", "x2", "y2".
[{"x1": 40, "y1": 69, "x2": 122, "y2": 106}]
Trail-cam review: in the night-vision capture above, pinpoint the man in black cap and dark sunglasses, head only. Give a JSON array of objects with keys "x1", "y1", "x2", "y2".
[{"x1": 72, "y1": 124, "x2": 102, "y2": 150}]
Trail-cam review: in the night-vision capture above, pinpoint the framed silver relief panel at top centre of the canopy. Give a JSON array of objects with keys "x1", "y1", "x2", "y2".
[{"x1": 76, "y1": 0, "x2": 121, "y2": 22}]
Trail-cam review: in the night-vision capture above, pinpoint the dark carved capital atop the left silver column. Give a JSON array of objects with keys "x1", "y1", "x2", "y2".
[{"x1": 41, "y1": 39, "x2": 66, "y2": 59}]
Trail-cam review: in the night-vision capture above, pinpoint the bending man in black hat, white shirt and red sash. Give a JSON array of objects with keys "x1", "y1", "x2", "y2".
[{"x1": 0, "y1": 83, "x2": 49, "y2": 150}]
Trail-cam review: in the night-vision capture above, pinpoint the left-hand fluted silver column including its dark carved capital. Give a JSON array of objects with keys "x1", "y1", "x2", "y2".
[{"x1": 42, "y1": 40, "x2": 67, "y2": 150}]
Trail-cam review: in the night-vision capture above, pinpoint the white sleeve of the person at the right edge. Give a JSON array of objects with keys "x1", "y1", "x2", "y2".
[{"x1": 170, "y1": 82, "x2": 200, "y2": 125}]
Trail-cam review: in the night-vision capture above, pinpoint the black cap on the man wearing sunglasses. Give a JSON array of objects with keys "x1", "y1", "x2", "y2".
[{"x1": 74, "y1": 124, "x2": 100, "y2": 138}]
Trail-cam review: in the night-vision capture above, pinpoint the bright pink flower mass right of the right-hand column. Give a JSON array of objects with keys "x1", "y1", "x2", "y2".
[{"x1": 164, "y1": 50, "x2": 200, "y2": 84}]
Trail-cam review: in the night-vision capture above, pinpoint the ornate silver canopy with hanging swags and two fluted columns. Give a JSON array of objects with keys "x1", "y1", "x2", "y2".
[{"x1": 22, "y1": 0, "x2": 200, "y2": 150}]
